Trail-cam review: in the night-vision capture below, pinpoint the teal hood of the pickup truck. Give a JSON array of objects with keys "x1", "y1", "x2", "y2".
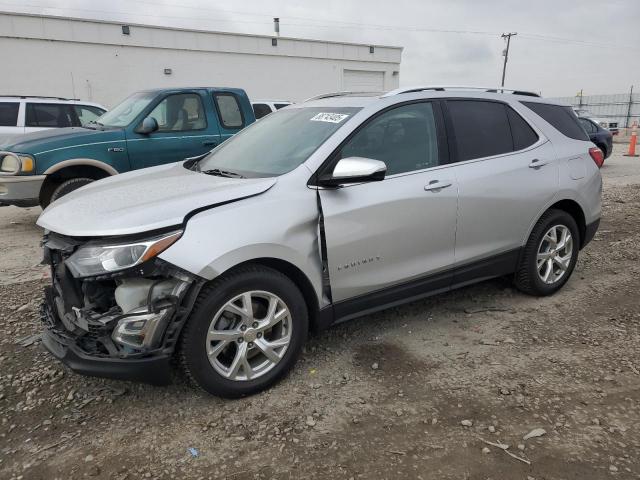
[{"x1": 0, "y1": 127, "x2": 124, "y2": 155}]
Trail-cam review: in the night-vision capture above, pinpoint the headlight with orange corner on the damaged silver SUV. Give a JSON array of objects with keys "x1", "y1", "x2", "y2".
[{"x1": 66, "y1": 230, "x2": 182, "y2": 278}]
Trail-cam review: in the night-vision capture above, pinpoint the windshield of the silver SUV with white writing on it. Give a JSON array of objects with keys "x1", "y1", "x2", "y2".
[{"x1": 196, "y1": 107, "x2": 360, "y2": 177}]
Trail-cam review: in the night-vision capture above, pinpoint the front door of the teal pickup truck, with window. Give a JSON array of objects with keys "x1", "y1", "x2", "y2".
[{"x1": 127, "y1": 92, "x2": 220, "y2": 169}]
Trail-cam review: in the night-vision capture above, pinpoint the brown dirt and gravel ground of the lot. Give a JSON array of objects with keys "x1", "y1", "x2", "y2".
[{"x1": 0, "y1": 145, "x2": 640, "y2": 480}]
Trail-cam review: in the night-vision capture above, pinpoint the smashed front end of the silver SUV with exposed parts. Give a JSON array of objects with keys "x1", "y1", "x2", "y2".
[{"x1": 41, "y1": 232, "x2": 204, "y2": 384}]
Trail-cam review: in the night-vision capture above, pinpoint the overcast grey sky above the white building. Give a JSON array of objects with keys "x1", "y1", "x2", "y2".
[{"x1": 0, "y1": 0, "x2": 640, "y2": 97}]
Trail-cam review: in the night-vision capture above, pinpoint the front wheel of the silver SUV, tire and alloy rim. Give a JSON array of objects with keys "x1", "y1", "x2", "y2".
[{"x1": 179, "y1": 265, "x2": 309, "y2": 398}]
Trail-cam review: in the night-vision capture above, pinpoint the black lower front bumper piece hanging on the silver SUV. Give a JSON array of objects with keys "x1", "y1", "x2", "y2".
[{"x1": 41, "y1": 303, "x2": 171, "y2": 385}]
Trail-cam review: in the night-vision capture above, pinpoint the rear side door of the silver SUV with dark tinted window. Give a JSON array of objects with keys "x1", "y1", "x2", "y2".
[{"x1": 446, "y1": 99, "x2": 558, "y2": 283}]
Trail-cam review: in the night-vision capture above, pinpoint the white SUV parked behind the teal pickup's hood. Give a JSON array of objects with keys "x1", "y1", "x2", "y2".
[{"x1": 0, "y1": 96, "x2": 107, "y2": 140}]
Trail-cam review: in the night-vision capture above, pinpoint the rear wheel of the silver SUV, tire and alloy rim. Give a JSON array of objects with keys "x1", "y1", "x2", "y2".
[{"x1": 515, "y1": 209, "x2": 580, "y2": 296}]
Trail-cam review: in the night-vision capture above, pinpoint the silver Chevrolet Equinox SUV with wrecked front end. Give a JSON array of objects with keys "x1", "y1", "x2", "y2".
[{"x1": 38, "y1": 86, "x2": 602, "y2": 397}]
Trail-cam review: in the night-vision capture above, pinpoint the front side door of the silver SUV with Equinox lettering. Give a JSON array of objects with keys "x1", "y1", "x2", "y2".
[{"x1": 320, "y1": 102, "x2": 458, "y2": 303}]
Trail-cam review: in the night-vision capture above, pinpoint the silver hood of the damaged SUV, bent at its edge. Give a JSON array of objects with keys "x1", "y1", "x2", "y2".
[{"x1": 37, "y1": 162, "x2": 276, "y2": 237}]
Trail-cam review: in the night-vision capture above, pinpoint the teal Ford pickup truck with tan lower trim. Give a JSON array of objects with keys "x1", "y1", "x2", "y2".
[{"x1": 0, "y1": 87, "x2": 255, "y2": 208}]
